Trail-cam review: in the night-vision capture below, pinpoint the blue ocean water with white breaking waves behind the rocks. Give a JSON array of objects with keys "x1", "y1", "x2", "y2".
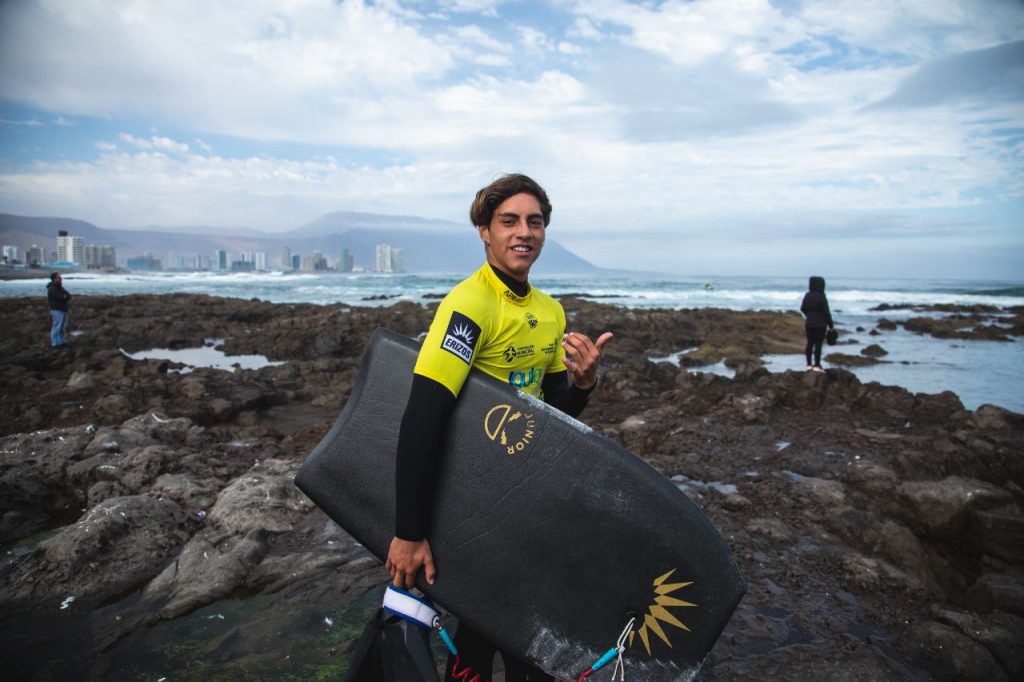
[{"x1": 0, "y1": 272, "x2": 1024, "y2": 413}]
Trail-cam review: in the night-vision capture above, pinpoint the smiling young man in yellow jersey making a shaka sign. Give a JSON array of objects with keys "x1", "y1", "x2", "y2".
[{"x1": 385, "y1": 174, "x2": 611, "y2": 682}]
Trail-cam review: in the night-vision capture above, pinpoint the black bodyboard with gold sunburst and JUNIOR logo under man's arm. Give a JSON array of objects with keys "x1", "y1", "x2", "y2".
[{"x1": 295, "y1": 329, "x2": 745, "y2": 682}]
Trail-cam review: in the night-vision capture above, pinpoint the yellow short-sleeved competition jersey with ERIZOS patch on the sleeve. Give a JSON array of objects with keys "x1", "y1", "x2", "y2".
[{"x1": 415, "y1": 263, "x2": 565, "y2": 397}]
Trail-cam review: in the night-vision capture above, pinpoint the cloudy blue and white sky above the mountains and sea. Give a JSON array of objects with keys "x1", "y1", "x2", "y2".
[{"x1": 0, "y1": 0, "x2": 1024, "y2": 280}]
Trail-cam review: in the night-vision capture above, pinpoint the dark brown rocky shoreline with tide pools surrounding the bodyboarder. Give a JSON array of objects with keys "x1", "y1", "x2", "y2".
[{"x1": 0, "y1": 295, "x2": 1024, "y2": 681}]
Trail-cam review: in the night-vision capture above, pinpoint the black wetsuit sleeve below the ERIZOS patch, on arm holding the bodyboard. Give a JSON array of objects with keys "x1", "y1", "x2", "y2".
[{"x1": 394, "y1": 374, "x2": 456, "y2": 541}]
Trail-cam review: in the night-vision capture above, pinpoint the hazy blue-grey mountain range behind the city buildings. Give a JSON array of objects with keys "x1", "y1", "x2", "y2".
[{"x1": 0, "y1": 211, "x2": 602, "y2": 274}]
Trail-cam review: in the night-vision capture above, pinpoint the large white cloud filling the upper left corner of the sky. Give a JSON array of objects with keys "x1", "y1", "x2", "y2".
[{"x1": 0, "y1": 0, "x2": 453, "y2": 140}]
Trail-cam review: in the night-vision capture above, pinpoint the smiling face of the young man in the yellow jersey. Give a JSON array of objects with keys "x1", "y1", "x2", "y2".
[{"x1": 479, "y1": 193, "x2": 547, "y2": 282}]
